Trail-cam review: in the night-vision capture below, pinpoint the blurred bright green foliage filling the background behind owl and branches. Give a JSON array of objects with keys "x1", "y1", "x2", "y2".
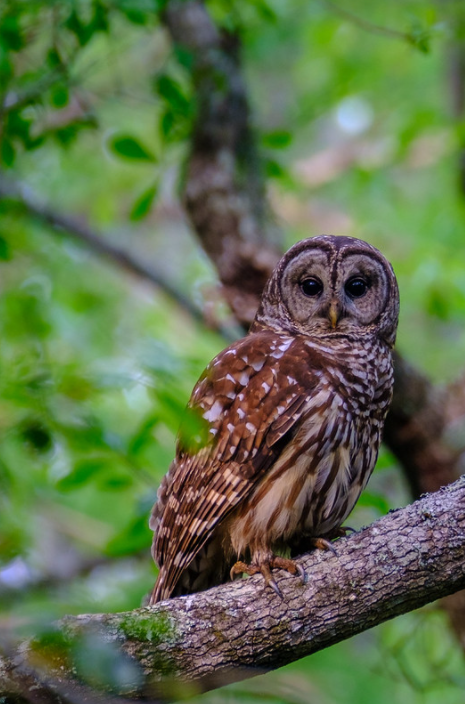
[{"x1": 0, "y1": 0, "x2": 465, "y2": 704}]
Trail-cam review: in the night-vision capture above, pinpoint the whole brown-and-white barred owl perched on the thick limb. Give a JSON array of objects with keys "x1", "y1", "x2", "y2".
[{"x1": 150, "y1": 236, "x2": 399, "y2": 604}]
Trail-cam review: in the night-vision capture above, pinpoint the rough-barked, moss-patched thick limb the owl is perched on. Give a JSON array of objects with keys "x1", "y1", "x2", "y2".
[{"x1": 0, "y1": 478, "x2": 465, "y2": 702}]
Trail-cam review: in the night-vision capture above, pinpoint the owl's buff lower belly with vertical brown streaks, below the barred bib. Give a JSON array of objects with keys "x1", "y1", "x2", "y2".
[{"x1": 234, "y1": 390, "x2": 379, "y2": 542}]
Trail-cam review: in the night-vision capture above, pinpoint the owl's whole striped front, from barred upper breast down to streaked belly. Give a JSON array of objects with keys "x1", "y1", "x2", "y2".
[{"x1": 228, "y1": 342, "x2": 392, "y2": 555}]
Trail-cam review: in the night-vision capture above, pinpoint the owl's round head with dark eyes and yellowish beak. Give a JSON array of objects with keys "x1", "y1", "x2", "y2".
[{"x1": 252, "y1": 235, "x2": 399, "y2": 346}]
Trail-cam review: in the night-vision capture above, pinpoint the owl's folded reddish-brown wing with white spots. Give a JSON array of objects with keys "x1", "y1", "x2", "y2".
[{"x1": 151, "y1": 332, "x2": 318, "y2": 603}]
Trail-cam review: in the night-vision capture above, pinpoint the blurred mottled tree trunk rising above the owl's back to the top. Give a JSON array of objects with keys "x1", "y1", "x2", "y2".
[{"x1": 165, "y1": 0, "x2": 279, "y2": 327}]
